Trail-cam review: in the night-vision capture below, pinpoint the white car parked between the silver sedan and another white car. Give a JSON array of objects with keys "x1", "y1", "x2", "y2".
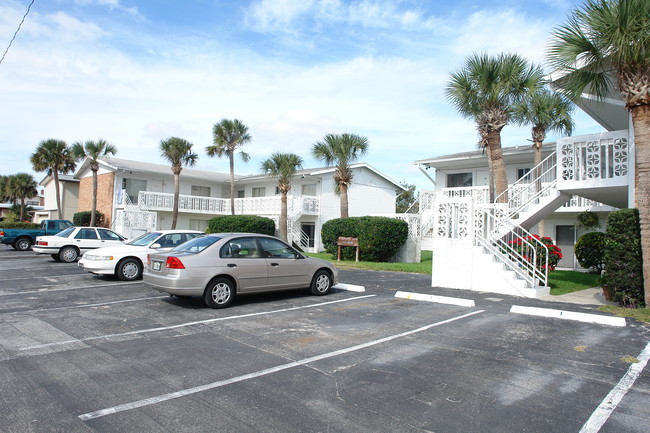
[{"x1": 79, "y1": 230, "x2": 204, "y2": 281}]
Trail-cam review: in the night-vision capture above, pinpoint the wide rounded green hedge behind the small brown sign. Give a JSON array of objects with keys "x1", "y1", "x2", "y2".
[{"x1": 321, "y1": 217, "x2": 408, "y2": 262}]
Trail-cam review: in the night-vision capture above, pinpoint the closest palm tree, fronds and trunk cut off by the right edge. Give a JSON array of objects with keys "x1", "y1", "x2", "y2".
[{"x1": 548, "y1": 0, "x2": 650, "y2": 308}]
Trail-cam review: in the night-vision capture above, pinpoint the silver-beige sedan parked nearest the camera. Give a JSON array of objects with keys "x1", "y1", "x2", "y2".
[{"x1": 143, "y1": 233, "x2": 338, "y2": 308}]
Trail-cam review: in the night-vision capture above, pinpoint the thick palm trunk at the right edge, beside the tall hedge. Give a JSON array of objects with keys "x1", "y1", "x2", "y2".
[{"x1": 631, "y1": 105, "x2": 650, "y2": 308}]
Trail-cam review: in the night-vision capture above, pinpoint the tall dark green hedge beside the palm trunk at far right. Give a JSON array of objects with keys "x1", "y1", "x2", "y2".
[{"x1": 603, "y1": 209, "x2": 644, "y2": 307}]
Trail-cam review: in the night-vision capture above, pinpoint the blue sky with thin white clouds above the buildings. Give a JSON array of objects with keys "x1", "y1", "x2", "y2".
[{"x1": 0, "y1": 0, "x2": 602, "y2": 189}]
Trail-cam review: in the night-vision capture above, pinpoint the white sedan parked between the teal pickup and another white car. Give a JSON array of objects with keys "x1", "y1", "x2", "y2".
[{"x1": 32, "y1": 227, "x2": 126, "y2": 263}]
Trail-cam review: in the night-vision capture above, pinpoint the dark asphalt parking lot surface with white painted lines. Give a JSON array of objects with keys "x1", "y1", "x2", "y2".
[{"x1": 0, "y1": 246, "x2": 650, "y2": 433}]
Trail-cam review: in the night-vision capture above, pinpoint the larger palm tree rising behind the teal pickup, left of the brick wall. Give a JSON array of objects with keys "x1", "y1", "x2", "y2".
[{"x1": 30, "y1": 138, "x2": 76, "y2": 218}]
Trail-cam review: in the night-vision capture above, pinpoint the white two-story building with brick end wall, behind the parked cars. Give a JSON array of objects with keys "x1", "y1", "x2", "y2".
[{"x1": 74, "y1": 157, "x2": 404, "y2": 251}]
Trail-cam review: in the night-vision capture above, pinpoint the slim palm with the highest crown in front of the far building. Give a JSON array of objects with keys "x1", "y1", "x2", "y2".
[{"x1": 205, "y1": 119, "x2": 252, "y2": 215}]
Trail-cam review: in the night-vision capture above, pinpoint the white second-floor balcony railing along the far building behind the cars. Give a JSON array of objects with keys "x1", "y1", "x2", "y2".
[{"x1": 131, "y1": 191, "x2": 320, "y2": 216}]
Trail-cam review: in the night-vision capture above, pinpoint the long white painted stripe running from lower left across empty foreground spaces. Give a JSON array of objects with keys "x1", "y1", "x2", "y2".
[{"x1": 79, "y1": 310, "x2": 485, "y2": 421}]
